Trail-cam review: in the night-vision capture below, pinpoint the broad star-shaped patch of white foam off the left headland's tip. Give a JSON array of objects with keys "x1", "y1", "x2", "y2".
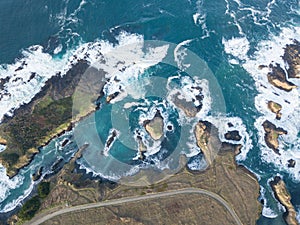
[{"x1": 94, "y1": 32, "x2": 168, "y2": 103}]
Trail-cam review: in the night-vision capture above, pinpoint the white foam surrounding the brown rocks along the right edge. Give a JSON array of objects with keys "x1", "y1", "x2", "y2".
[{"x1": 243, "y1": 27, "x2": 300, "y2": 181}]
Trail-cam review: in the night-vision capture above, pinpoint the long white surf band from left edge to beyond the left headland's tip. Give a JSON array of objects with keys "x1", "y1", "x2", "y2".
[{"x1": 0, "y1": 32, "x2": 168, "y2": 123}]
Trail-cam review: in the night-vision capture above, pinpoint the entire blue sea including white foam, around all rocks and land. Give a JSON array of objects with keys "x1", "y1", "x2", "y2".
[{"x1": 0, "y1": 0, "x2": 300, "y2": 224}]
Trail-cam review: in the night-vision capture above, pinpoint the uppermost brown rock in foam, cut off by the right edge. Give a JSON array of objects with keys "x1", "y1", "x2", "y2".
[{"x1": 283, "y1": 40, "x2": 300, "y2": 78}]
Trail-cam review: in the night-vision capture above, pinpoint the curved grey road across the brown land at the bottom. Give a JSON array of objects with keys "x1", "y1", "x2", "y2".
[{"x1": 24, "y1": 188, "x2": 243, "y2": 225}]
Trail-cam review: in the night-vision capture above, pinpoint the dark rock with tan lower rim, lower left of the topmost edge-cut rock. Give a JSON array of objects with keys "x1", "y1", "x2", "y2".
[{"x1": 268, "y1": 64, "x2": 297, "y2": 92}]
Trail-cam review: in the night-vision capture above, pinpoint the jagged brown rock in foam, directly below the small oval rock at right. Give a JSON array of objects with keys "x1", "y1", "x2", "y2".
[{"x1": 262, "y1": 120, "x2": 287, "y2": 155}]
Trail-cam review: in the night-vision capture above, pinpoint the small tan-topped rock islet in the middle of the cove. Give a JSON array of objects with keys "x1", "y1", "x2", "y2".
[{"x1": 143, "y1": 110, "x2": 164, "y2": 141}]
